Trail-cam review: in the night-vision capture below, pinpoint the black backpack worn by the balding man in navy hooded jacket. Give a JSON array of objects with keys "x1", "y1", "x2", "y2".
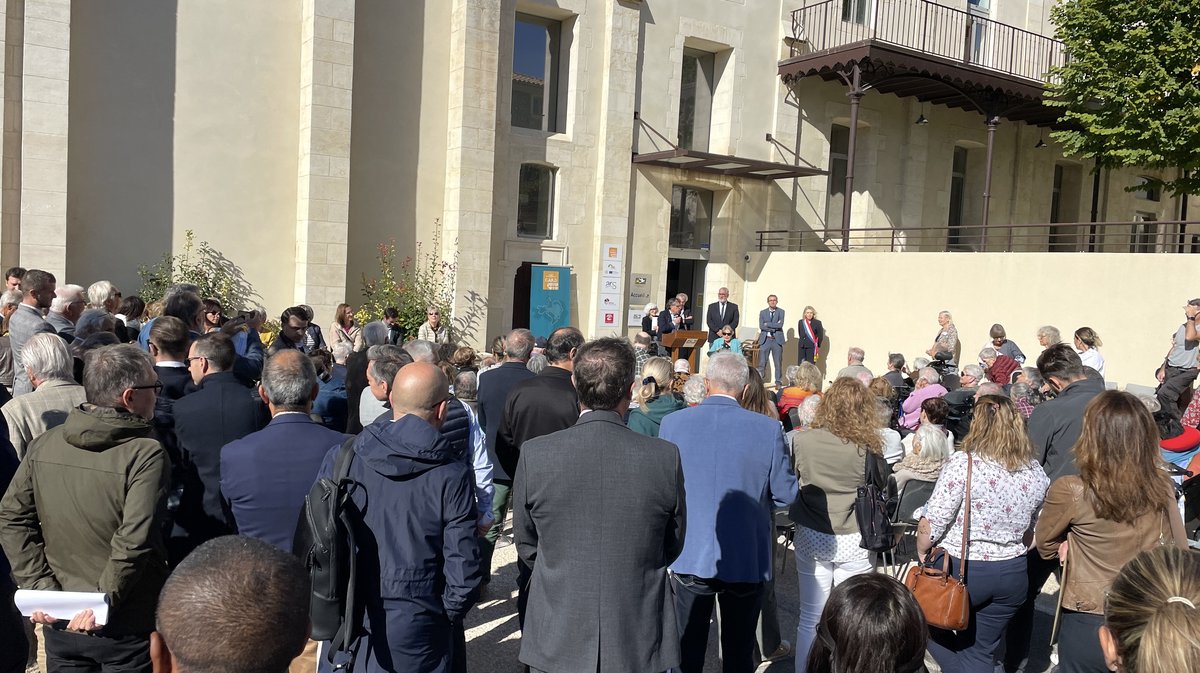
[{"x1": 292, "y1": 437, "x2": 360, "y2": 662}]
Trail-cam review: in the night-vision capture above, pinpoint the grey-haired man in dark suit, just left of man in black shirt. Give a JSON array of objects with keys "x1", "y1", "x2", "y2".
[{"x1": 478, "y1": 328, "x2": 534, "y2": 583}]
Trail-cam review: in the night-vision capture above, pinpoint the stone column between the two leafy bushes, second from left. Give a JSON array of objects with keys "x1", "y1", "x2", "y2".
[{"x1": 295, "y1": 0, "x2": 354, "y2": 324}]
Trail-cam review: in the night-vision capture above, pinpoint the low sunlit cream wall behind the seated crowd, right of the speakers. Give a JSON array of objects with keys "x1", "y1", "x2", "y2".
[{"x1": 731, "y1": 252, "x2": 1196, "y2": 386}]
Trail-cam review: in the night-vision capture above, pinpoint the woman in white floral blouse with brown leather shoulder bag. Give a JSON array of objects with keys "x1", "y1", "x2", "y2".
[{"x1": 917, "y1": 395, "x2": 1050, "y2": 672}]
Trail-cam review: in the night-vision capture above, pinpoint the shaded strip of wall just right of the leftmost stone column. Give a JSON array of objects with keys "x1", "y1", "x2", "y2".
[{"x1": 60, "y1": 0, "x2": 174, "y2": 295}]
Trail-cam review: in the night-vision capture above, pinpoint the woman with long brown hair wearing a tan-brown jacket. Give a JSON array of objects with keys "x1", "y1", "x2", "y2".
[{"x1": 1036, "y1": 390, "x2": 1187, "y2": 673}]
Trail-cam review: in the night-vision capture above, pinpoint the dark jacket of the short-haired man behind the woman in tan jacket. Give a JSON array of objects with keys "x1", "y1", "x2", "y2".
[{"x1": 1027, "y1": 379, "x2": 1104, "y2": 482}]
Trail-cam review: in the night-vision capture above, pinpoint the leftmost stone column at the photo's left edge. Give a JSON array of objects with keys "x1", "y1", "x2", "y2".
[{"x1": 12, "y1": 0, "x2": 71, "y2": 275}]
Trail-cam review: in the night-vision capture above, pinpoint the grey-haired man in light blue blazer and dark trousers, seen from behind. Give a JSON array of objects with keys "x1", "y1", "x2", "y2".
[{"x1": 659, "y1": 352, "x2": 797, "y2": 673}]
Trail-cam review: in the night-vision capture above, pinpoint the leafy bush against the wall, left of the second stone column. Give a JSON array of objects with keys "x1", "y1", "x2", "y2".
[{"x1": 138, "y1": 229, "x2": 262, "y2": 314}]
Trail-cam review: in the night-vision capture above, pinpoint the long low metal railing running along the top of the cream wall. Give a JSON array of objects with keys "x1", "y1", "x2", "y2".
[{"x1": 755, "y1": 220, "x2": 1200, "y2": 254}]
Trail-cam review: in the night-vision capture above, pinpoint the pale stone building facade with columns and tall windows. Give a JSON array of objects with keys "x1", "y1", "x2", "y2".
[{"x1": 0, "y1": 0, "x2": 1186, "y2": 345}]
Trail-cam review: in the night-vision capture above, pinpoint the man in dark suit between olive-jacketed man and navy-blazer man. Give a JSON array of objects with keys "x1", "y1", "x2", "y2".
[{"x1": 168, "y1": 332, "x2": 268, "y2": 565}]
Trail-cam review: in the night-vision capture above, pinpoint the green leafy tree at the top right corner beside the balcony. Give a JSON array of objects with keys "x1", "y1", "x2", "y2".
[{"x1": 1046, "y1": 0, "x2": 1200, "y2": 193}]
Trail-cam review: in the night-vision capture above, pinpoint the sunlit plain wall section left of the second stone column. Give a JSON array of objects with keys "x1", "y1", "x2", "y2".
[{"x1": 173, "y1": 0, "x2": 304, "y2": 314}]
